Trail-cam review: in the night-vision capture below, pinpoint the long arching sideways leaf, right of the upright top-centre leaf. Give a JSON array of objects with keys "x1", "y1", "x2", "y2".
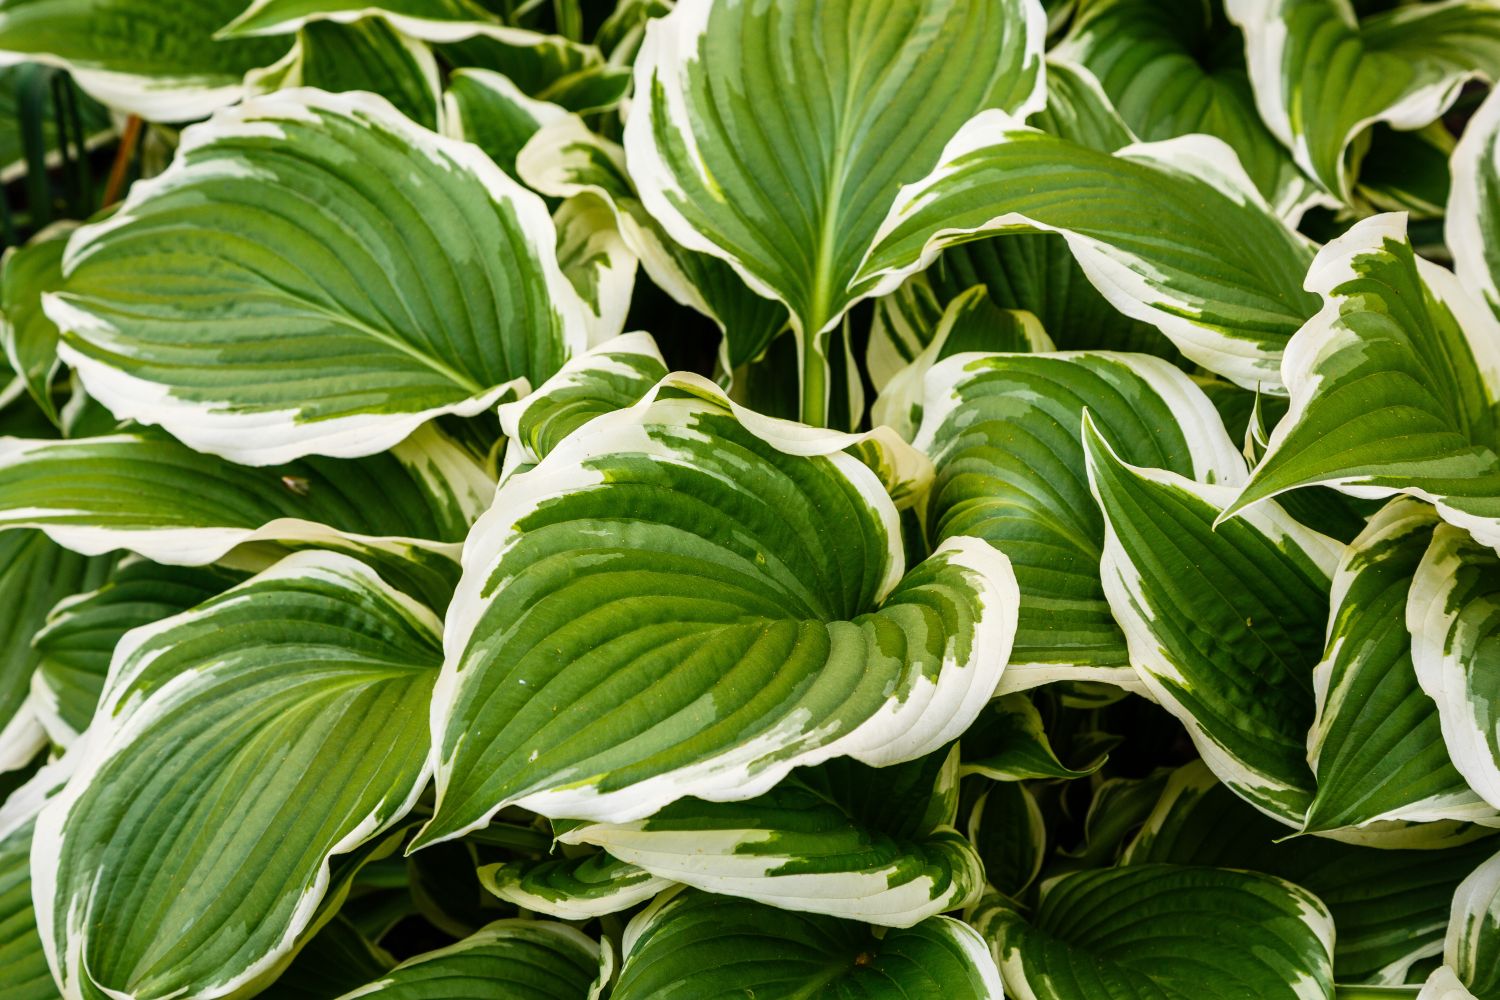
[{"x1": 855, "y1": 111, "x2": 1317, "y2": 388}]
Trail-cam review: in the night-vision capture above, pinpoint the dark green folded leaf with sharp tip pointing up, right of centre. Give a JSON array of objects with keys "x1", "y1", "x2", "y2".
[{"x1": 1083, "y1": 421, "x2": 1344, "y2": 826}]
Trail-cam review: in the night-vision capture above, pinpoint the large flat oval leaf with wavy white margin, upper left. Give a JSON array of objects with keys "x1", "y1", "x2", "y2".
[{"x1": 45, "y1": 90, "x2": 587, "y2": 465}]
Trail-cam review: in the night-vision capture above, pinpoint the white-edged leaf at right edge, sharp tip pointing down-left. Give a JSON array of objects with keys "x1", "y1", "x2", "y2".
[{"x1": 1226, "y1": 214, "x2": 1500, "y2": 544}]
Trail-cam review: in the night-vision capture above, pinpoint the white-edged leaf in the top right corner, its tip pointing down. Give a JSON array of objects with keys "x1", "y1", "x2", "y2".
[{"x1": 1224, "y1": 0, "x2": 1500, "y2": 201}]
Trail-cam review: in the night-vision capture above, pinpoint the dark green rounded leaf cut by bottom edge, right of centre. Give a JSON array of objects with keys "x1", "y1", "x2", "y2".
[{"x1": 974, "y1": 865, "x2": 1334, "y2": 1000}]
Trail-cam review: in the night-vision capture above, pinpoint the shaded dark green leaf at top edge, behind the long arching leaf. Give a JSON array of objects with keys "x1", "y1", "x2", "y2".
[{"x1": 1052, "y1": 0, "x2": 1313, "y2": 219}]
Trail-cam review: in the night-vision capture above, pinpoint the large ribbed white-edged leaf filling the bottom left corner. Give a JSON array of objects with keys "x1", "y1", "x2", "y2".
[{"x1": 33, "y1": 552, "x2": 443, "y2": 999}]
